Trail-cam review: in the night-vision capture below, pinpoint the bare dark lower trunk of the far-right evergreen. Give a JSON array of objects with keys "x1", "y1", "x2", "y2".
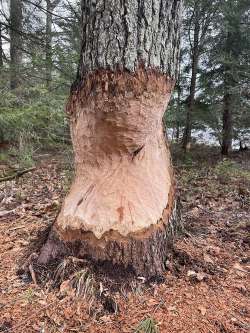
[{"x1": 221, "y1": 93, "x2": 233, "y2": 156}]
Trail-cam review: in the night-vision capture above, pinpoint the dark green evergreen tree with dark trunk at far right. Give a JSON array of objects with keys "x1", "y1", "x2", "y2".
[{"x1": 202, "y1": 0, "x2": 250, "y2": 155}]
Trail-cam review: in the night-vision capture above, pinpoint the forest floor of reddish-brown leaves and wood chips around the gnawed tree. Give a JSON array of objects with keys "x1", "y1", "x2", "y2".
[{"x1": 0, "y1": 147, "x2": 250, "y2": 333}]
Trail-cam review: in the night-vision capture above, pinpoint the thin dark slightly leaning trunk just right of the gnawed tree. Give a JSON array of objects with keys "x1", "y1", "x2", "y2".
[{"x1": 182, "y1": 5, "x2": 200, "y2": 151}]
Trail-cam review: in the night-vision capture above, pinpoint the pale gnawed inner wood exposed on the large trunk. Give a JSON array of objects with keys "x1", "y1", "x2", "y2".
[{"x1": 57, "y1": 71, "x2": 172, "y2": 239}]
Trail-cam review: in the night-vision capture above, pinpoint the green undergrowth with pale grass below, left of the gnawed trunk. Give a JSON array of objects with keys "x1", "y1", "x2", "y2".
[{"x1": 0, "y1": 85, "x2": 71, "y2": 168}]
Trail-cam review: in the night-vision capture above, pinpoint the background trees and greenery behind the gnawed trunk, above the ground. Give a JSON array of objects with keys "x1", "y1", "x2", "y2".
[{"x1": 0, "y1": 0, "x2": 250, "y2": 160}]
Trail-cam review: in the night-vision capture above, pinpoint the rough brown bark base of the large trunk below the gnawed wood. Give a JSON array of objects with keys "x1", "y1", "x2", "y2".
[{"x1": 37, "y1": 199, "x2": 182, "y2": 279}]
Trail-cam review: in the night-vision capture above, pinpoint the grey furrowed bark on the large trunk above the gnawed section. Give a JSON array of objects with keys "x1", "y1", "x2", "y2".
[{"x1": 78, "y1": 0, "x2": 181, "y2": 79}]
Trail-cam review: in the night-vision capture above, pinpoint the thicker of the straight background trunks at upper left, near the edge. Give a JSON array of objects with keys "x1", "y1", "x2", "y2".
[{"x1": 10, "y1": 0, "x2": 22, "y2": 89}]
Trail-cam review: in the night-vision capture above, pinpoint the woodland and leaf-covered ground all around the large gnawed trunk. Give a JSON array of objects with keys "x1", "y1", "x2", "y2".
[{"x1": 0, "y1": 0, "x2": 250, "y2": 333}]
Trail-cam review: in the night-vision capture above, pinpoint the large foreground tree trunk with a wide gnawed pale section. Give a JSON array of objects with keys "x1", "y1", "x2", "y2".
[{"x1": 38, "y1": 0, "x2": 184, "y2": 277}]
